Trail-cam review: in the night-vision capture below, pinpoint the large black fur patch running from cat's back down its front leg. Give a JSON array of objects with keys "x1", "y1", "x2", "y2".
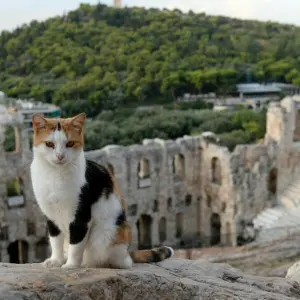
[{"x1": 69, "y1": 160, "x2": 113, "y2": 244}]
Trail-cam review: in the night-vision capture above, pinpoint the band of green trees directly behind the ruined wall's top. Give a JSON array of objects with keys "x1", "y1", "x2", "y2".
[{"x1": 4, "y1": 108, "x2": 266, "y2": 151}]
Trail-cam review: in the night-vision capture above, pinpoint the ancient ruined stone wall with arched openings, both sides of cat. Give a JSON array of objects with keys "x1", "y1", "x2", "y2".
[{"x1": 0, "y1": 97, "x2": 300, "y2": 262}]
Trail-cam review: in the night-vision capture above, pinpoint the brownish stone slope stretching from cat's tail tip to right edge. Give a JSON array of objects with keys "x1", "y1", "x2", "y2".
[{"x1": 175, "y1": 234, "x2": 300, "y2": 277}]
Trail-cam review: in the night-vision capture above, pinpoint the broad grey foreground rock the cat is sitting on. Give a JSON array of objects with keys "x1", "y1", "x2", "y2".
[{"x1": 0, "y1": 259, "x2": 300, "y2": 300}]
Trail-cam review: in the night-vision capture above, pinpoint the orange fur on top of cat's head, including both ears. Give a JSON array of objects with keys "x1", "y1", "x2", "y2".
[{"x1": 32, "y1": 113, "x2": 86, "y2": 148}]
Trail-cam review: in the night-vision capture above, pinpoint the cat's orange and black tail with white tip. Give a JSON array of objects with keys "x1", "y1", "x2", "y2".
[{"x1": 129, "y1": 246, "x2": 174, "y2": 263}]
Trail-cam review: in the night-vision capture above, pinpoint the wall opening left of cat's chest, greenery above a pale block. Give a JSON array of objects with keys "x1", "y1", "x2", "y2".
[{"x1": 6, "y1": 177, "x2": 25, "y2": 208}]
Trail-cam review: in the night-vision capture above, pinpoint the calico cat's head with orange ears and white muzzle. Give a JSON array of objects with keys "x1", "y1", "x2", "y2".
[{"x1": 32, "y1": 113, "x2": 86, "y2": 166}]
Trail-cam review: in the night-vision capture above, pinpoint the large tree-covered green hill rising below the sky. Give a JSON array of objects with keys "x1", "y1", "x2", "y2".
[{"x1": 0, "y1": 4, "x2": 300, "y2": 116}]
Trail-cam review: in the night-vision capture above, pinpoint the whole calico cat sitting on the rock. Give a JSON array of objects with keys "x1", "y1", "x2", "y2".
[{"x1": 30, "y1": 113, "x2": 174, "y2": 269}]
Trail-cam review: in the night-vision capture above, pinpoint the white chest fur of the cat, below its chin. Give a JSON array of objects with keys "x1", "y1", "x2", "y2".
[{"x1": 31, "y1": 161, "x2": 82, "y2": 233}]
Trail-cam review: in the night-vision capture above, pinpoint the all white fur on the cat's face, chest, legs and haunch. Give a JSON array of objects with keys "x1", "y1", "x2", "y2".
[{"x1": 31, "y1": 131, "x2": 132, "y2": 268}]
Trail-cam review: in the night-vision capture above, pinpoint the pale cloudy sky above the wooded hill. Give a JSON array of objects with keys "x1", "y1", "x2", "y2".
[{"x1": 0, "y1": 0, "x2": 300, "y2": 30}]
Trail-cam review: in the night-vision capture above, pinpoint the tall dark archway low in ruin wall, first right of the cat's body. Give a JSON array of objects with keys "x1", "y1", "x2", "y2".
[{"x1": 136, "y1": 215, "x2": 152, "y2": 250}]
